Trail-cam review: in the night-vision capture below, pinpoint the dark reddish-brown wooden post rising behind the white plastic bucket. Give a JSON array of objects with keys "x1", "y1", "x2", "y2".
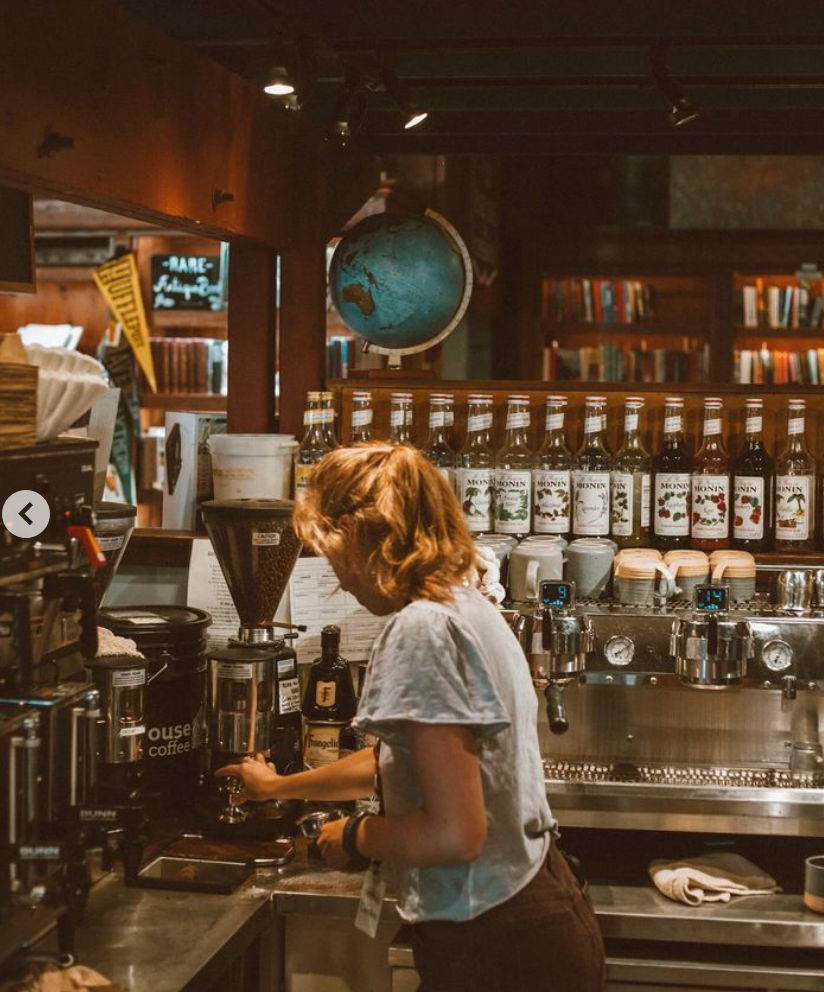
[{"x1": 228, "y1": 242, "x2": 277, "y2": 434}]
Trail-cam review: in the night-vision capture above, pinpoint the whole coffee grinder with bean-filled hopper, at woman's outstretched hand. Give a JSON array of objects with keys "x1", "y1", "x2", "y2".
[{"x1": 202, "y1": 499, "x2": 302, "y2": 836}]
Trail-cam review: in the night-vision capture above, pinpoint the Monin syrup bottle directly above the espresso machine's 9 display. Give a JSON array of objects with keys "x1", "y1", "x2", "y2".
[{"x1": 532, "y1": 396, "x2": 572, "y2": 537}]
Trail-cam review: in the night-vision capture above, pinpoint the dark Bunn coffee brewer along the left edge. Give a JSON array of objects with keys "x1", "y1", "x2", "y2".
[{"x1": 0, "y1": 439, "x2": 106, "y2": 966}]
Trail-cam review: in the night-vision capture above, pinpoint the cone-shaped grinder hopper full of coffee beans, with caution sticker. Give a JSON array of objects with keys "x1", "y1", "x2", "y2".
[{"x1": 201, "y1": 499, "x2": 301, "y2": 644}]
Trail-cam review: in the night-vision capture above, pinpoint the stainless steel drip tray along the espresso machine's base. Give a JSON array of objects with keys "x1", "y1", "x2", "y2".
[{"x1": 544, "y1": 760, "x2": 824, "y2": 836}]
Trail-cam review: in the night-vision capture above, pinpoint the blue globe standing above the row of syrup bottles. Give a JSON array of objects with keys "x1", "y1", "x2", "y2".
[{"x1": 329, "y1": 213, "x2": 472, "y2": 352}]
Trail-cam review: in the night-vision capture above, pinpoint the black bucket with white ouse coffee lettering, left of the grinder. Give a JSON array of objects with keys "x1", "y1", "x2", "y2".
[{"x1": 98, "y1": 606, "x2": 212, "y2": 813}]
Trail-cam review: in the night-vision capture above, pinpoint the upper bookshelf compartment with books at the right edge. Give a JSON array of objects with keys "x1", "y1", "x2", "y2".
[{"x1": 733, "y1": 266, "x2": 824, "y2": 336}]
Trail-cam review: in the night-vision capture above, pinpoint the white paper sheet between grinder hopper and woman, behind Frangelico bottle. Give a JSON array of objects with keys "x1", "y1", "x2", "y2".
[{"x1": 289, "y1": 558, "x2": 389, "y2": 661}]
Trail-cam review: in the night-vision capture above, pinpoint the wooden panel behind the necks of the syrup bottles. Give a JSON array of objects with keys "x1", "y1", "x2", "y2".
[{"x1": 330, "y1": 377, "x2": 824, "y2": 457}]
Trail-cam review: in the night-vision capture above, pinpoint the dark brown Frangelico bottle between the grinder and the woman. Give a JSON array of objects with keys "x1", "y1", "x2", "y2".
[{"x1": 301, "y1": 626, "x2": 357, "y2": 768}]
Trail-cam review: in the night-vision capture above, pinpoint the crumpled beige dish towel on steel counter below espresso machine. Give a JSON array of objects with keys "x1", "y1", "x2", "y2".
[{"x1": 649, "y1": 853, "x2": 781, "y2": 906}]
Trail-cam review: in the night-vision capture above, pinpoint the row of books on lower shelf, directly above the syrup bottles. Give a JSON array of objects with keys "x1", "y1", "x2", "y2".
[{"x1": 543, "y1": 342, "x2": 709, "y2": 383}]
